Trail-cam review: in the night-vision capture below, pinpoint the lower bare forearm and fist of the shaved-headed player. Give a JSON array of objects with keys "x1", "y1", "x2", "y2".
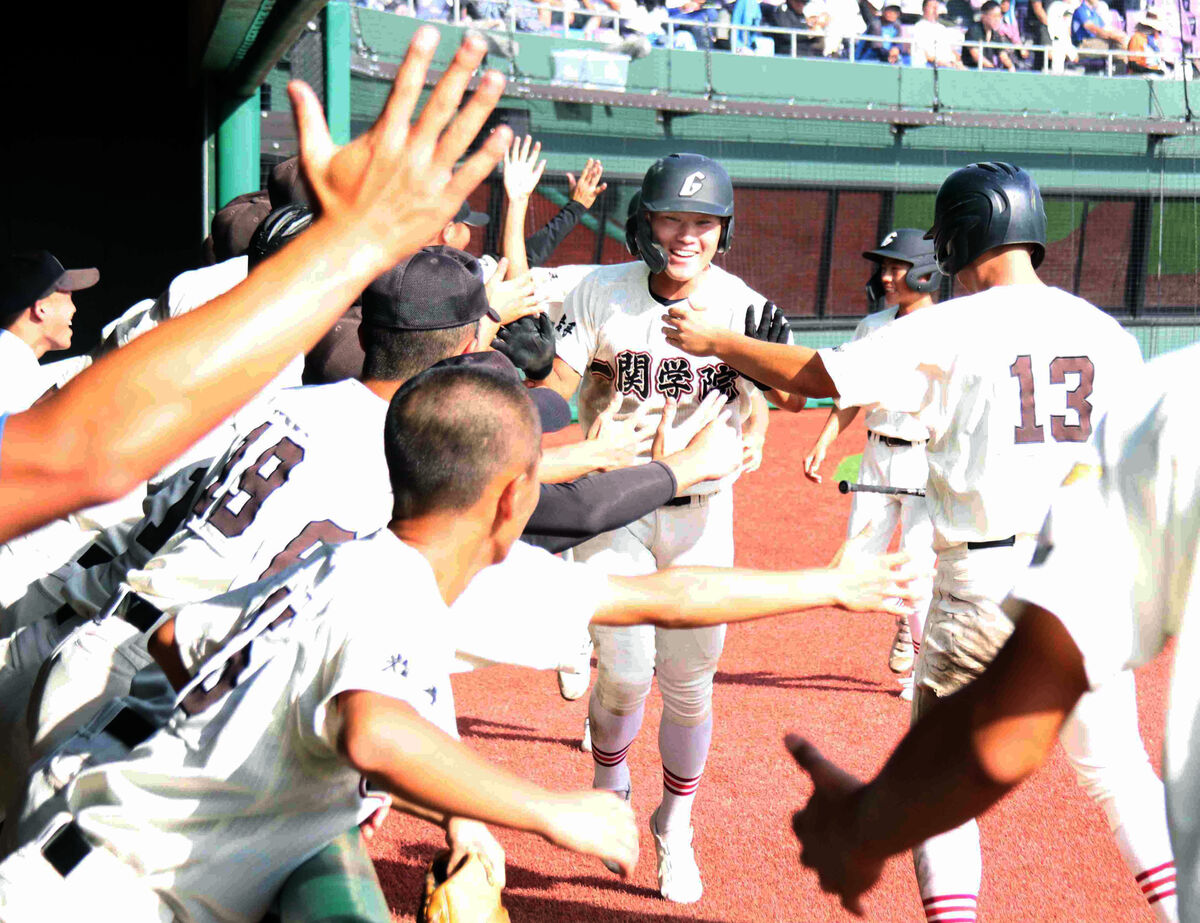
[{"x1": 336, "y1": 690, "x2": 637, "y2": 875}]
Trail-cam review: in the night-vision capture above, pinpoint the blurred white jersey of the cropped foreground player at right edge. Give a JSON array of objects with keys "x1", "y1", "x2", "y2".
[{"x1": 1010, "y1": 347, "x2": 1200, "y2": 909}]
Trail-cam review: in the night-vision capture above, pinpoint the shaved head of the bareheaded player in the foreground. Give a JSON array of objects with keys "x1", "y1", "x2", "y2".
[{"x1": 384, "y1": 366, "x2": 541, "y2": 521}]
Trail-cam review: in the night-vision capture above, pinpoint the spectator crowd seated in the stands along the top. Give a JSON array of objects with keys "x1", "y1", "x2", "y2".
[{"x1": 355, "y1": 0, "x2": 1194, "y2": 77}]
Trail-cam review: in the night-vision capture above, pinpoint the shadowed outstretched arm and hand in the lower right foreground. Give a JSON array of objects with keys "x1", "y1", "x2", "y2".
[{"x1": 787, "y1": 606, "x2": 1087, "y2": 913}]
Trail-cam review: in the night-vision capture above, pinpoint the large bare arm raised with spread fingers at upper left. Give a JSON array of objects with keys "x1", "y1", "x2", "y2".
[{"x1": 0, "y1": 26, "x2": 510, "y2": 540}]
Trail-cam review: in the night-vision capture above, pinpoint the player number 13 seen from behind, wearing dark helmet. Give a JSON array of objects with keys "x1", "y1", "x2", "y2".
[{"x1": 666, "y1": 163, "x2": 1172, "y2": 921}]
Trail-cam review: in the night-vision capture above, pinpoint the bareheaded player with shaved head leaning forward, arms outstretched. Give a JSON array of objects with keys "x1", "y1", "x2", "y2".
[{"x1": 0, "y1": 367, "x2": 911, "y2": 921}]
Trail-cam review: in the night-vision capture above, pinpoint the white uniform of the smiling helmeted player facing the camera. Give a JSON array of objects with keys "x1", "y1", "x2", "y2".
[{"x1": 558, "y1": 255, "x2": 766, "y2": 900}]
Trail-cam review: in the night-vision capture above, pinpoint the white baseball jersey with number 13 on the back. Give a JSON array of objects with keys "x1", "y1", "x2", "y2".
[{"x1": 820, "y1": 286, "x2": 1141, "y2": 550}]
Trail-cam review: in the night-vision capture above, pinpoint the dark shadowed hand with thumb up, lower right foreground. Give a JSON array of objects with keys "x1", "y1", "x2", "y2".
[{"x1": 786, "y1": 735, "x2": 883, "y2": 917}]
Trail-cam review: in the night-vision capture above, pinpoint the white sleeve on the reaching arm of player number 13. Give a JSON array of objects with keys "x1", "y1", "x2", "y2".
[{"x1": 817, "y1": 317, "x2": 948, "y2": 421}]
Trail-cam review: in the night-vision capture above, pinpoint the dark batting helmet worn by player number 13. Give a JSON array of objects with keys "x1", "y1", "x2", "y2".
[{"x1": 925, "y1": 163, "x2": 1046, "y2": 276}]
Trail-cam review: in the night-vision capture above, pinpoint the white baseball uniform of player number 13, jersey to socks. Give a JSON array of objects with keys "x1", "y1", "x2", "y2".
[{"x1": 820, "y1": 280, "x2": 1170, "y2": 921}]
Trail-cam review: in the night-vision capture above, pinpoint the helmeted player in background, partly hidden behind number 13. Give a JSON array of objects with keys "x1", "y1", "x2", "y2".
[{"x1": 804, "y1": 228, "x2": 942, "y2": 699}]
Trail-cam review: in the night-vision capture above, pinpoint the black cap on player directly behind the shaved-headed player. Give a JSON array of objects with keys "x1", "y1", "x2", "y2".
[{"x1": 362, "y1": 245, "x2": 500, "y2": 330}]
